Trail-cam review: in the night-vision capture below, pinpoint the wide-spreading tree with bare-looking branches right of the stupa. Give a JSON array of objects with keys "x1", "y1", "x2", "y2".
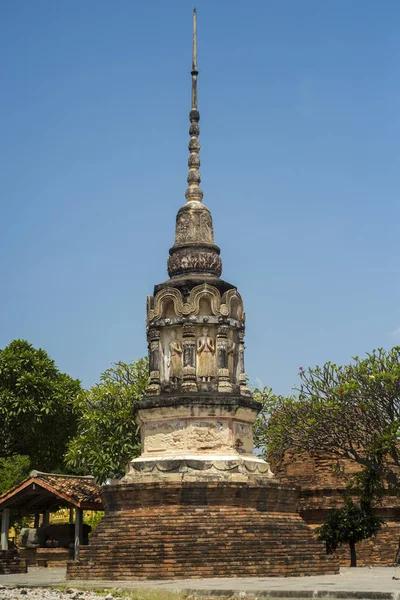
[{"x1": 255, "y1": 346, "x2": 400, "y2": 486}]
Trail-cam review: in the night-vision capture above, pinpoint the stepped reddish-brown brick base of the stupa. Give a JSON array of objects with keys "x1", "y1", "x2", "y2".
[{"x1": 67, "y1": 482, "x2": 339, "y2": 580}]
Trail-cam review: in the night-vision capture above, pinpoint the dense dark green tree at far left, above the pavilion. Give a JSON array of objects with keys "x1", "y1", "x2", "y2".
[{"x1": 0, "y1": 340, "x2": 81, "y2": 471}]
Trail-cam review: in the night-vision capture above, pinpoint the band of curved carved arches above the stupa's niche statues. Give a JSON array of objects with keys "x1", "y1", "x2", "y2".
[{"x1": 147, "y1": 283, "x2": 245, "y2": 323}]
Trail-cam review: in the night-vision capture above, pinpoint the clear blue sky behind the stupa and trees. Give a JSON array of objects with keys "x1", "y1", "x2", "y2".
[{"x1": 0, "y1": 0, "x2": 400, "y2": 393}]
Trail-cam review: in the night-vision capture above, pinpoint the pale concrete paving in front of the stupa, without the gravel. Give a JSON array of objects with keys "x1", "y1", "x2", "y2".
[{"x1": 0, "y1": 567, "x2": 400, "y2": 600}]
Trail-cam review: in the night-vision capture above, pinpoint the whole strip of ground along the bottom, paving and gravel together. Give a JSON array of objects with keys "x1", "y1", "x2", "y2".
[{"x1": 0, "y1": 567, "x2": 400, "y2": 600}]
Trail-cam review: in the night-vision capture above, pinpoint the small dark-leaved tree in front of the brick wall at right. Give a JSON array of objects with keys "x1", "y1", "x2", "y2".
[{"x1": 315, "y1": 468, "x2": 384, "y2": 567}]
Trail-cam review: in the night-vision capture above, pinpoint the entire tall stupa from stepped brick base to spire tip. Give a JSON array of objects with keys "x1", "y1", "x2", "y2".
[{"x1": 68, "y1": 10, "x2": 339, "y2": 580}]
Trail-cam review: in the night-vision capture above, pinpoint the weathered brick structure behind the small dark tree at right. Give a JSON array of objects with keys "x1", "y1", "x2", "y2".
[{"x1": 272, "y1": 452, "x2": 400, "y2": 566}]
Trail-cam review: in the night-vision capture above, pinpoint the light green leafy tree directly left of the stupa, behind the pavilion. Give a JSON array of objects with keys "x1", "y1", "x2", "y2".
[{"x1": 66, "y1": 359, "x2": 148, "y2": 483}]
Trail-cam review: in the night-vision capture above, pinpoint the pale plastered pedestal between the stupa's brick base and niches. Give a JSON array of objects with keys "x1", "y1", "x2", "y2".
[{"x1": 129, "y1": 392, "x2": 273, "y2": 483}]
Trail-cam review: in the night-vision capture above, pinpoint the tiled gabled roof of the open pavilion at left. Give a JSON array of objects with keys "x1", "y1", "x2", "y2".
[{"x1": 0, "y1": 471, "x2": 103, "y2": 514}]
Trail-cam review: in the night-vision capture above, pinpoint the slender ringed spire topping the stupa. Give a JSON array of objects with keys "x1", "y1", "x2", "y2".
[{"x1": 185, "y1": 9, "x2": 203, "y2": 202}]
